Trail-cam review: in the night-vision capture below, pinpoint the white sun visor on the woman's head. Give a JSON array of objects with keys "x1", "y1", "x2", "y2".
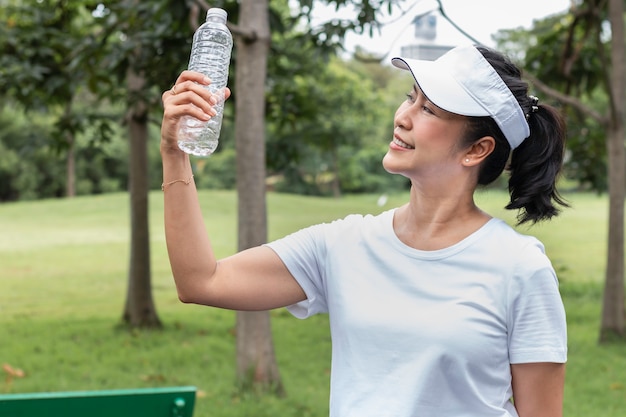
[{"x1": 391, "y1": 45, "x2": 530, "y2": 149}]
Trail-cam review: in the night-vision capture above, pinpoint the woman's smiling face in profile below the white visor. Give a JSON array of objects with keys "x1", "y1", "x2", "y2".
[{"x1": 383, "y1": 85, "x2": 467, "y2": 179}]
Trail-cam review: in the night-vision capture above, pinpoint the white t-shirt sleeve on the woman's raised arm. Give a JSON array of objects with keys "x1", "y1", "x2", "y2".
[{"x1": 266, "y1": 224, "x2": 328, "y2": 319}]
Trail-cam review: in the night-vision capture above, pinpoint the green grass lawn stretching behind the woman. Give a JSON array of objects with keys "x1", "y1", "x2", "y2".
[{"x1": 0, "y1": 191, "x2": 626, "y2": 417}]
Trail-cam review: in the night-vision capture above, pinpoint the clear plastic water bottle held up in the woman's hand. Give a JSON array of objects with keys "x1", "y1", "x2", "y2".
[{"x1": 178, "y1": 8, "x2": 233, "y2": 156}]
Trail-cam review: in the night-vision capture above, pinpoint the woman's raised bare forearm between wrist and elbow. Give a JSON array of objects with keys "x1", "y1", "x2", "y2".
[{"x1": 161, "y1": 151, "x2": 216, "y2": 302}]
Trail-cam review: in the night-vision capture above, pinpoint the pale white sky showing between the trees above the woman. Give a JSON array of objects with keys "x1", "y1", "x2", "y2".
[{"x1": 306, "y1": 0, "x2": 571, "y2": 59}]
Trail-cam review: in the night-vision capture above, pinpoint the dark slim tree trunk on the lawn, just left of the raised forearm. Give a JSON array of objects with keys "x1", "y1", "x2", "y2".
[{"x1": 123, "y1": 63, "x2": 161, "y2": 327}]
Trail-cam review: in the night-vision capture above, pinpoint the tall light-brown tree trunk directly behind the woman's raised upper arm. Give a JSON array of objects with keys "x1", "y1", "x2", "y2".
[{"x1": 234, "y1": 0, "x2": 283, "y2": 394}]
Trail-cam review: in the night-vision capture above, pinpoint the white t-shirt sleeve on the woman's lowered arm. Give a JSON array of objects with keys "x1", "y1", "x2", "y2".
[{"x1": 508, "y1": 243, "x2": 567, "y2": 364}]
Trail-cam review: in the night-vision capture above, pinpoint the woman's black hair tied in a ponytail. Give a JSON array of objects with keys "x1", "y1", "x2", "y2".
[{"x1": 463, "y1": 46, "x2": 569, "y2": 224}]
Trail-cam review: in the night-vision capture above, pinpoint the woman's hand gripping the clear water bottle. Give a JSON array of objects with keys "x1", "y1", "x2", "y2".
[{"x1": 161, "y1": 71, "x2": 230, "y2": 152}]
